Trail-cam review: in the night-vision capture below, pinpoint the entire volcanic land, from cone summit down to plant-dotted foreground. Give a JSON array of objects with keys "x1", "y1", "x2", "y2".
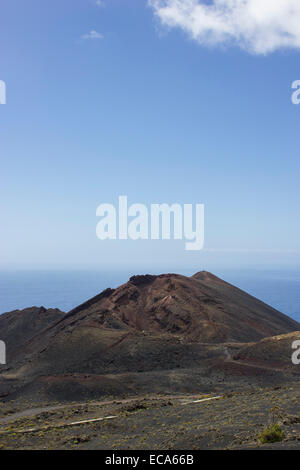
[{"x1": 0, "y1": 272, "x2": 300, "y2": 449}]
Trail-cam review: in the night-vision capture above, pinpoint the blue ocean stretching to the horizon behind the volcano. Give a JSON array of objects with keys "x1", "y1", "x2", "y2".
[{"x1": 0, "y1": 269, "x2": 300, "y2": 321}]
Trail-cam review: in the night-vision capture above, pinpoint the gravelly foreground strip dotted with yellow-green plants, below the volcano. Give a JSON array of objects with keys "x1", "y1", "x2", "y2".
[{"x1": 0, "y1": 383, "x2": 300, "y2": 451}]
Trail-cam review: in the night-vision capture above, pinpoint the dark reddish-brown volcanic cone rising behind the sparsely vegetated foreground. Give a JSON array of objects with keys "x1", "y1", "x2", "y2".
[{"x1": 0, "y1": 272, "x2": 300, "y2": 399}]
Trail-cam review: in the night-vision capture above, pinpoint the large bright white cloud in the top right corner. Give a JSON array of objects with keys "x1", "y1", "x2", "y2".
[{"x1": 148, "y1": 0, "x2": 300, "y2": 54}]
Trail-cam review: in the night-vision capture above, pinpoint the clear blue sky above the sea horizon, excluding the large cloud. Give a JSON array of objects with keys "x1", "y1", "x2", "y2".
[{"x1": 0, "y1": 0, "x2": 300, "y2": 271}]
